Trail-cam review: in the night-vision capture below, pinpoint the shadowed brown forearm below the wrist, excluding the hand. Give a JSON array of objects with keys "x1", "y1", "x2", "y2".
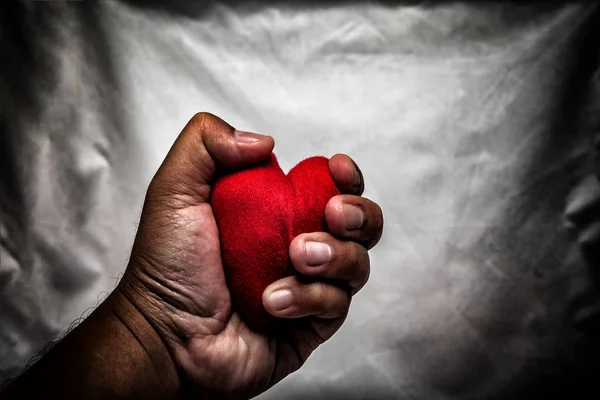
[{"x1": 1, "y1": 290, "x2": 181, "y2": 400}]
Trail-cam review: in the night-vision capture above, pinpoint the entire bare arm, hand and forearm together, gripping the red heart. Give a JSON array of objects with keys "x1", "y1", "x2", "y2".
[{"x1": 2, "y1": 113, "x2": 383, "y2": 399}]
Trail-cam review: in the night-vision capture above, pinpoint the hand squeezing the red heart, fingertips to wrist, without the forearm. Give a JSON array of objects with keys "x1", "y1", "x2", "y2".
[{"x1": 118, "y1": 114, "x2": 383, "y2": 398}]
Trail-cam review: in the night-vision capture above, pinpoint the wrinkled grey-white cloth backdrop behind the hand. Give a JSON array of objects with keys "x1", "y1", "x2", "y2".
[{"x1": 0, "y1": 0, "x2": 600, "y2": 399}]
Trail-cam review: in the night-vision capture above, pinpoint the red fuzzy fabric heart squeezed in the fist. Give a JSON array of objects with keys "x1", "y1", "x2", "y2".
[{"x1": 211, "y1": 153, "x2": 340, "y2": 332}]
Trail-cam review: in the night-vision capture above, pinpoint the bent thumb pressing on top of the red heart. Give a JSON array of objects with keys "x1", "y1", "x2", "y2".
[{"x1": 148, "y1": 113, "x2": 275, "y2": 204}]
